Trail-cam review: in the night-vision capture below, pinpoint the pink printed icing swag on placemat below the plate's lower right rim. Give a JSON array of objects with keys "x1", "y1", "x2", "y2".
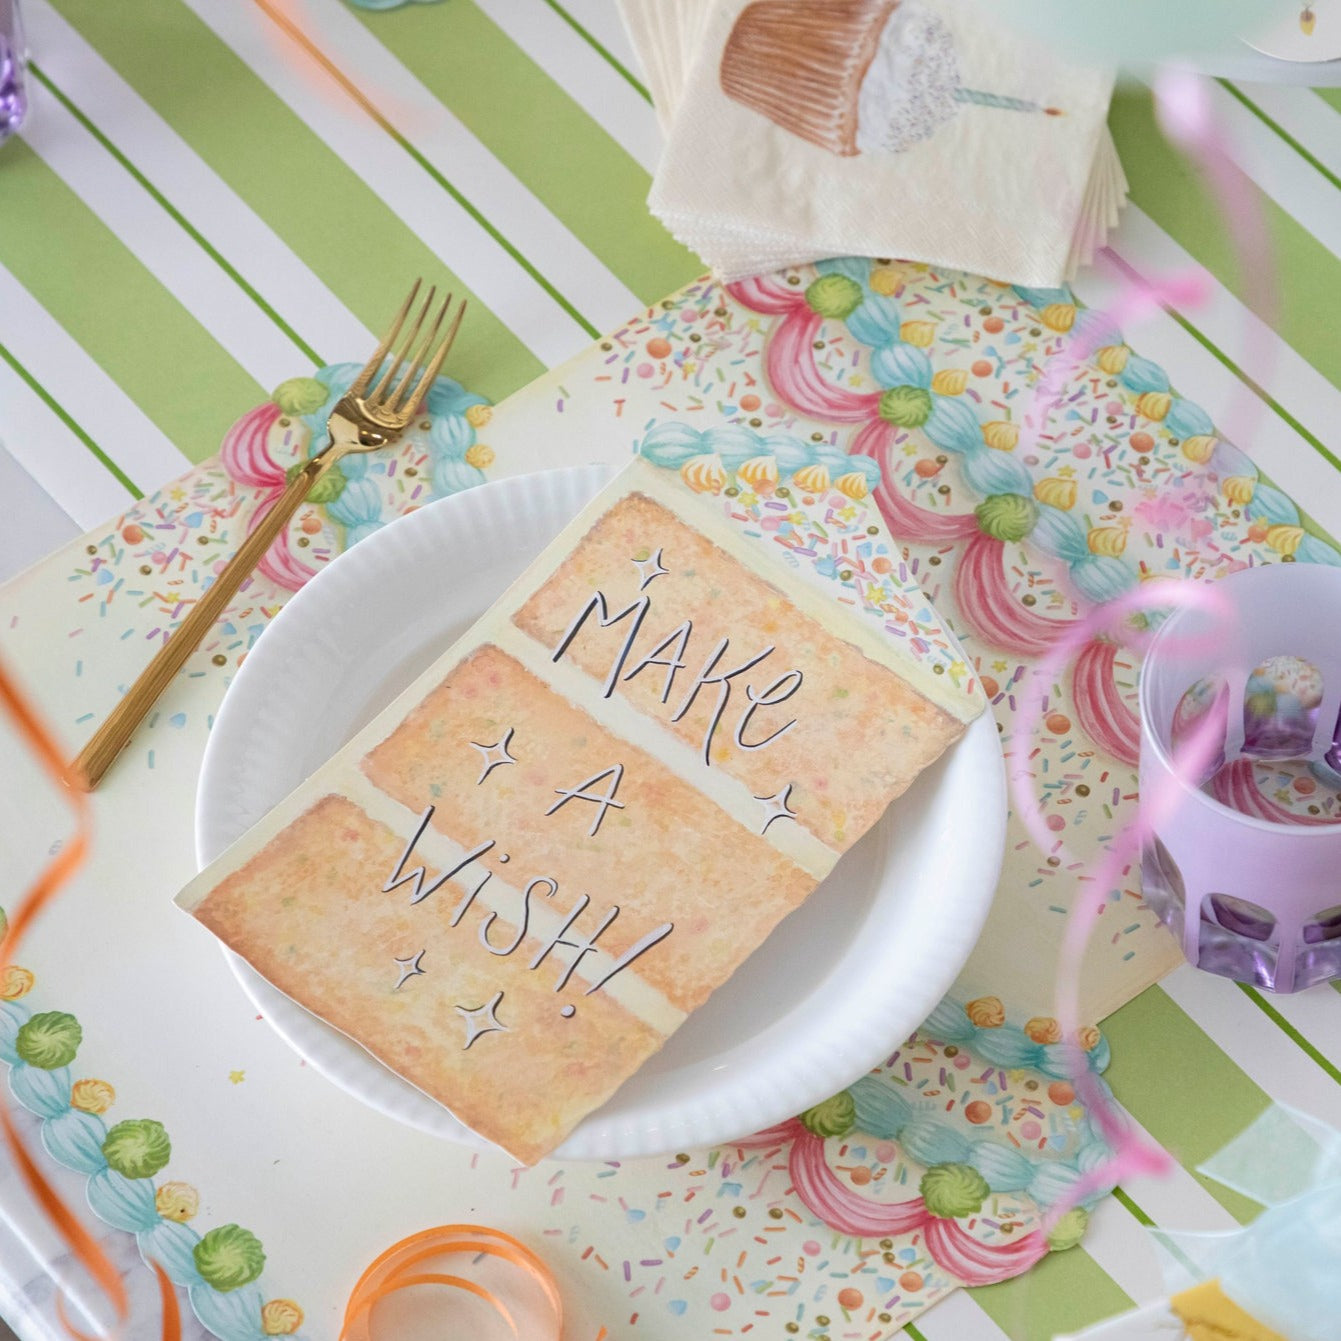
[{"x1": 736, "y1": 1118, "x2": 1047, "y2": 1285}]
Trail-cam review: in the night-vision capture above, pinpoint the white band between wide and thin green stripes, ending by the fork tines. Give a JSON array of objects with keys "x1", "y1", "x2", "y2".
[{"x1": 24, "y1": 0, "x2": 375, "y2": 367}]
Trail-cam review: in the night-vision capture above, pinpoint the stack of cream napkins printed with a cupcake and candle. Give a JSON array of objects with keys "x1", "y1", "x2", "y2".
[{"x1": 620, "y1": 0, "x2": 1126, "y2": 288}]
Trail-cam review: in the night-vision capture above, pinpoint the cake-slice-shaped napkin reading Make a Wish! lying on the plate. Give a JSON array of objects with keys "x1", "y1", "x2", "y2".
[{"x1": 178, "y1": 447, "x2": 984, "y2": 1164}]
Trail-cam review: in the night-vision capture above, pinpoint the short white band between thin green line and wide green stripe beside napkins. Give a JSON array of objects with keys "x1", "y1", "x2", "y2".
[{"x1": 476, "y1": 0, "x2": 661, "y2": 172}]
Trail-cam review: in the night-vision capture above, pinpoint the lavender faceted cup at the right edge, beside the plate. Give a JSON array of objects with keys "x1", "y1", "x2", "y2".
[{"x1": 1140, "y1": 563, "x2": 1341, "y2": 992}]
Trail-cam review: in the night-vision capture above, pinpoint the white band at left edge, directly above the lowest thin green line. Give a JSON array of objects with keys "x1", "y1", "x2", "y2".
[{"x1": 0, "y1": 266, "x2": 190, "y2": 504}]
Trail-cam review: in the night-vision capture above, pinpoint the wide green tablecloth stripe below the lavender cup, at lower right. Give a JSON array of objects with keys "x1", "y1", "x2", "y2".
[{"x1": 1104, "y1": 987, "x2": 1271, "y2": 1224}]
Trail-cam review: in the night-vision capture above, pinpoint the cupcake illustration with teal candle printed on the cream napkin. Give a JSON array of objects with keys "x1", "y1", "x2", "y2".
[{"x1": 721, "y1": 0, "x2": 1062, "y2": 157}]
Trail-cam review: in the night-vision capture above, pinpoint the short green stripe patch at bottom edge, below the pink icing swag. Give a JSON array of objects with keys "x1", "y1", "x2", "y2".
[{"x1": 968, "y1": 1248, "x2": 1134, "y2": 1341}]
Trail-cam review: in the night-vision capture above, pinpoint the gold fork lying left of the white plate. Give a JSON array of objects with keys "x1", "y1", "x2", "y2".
[{"x1": 74, "y1": 280, "x2": 465, "y2": 791}]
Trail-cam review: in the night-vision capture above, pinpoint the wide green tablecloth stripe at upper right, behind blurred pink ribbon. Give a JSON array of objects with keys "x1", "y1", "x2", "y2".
[{"x1": 1109, "y1": 87, "x2": 1341, "y2": 388}]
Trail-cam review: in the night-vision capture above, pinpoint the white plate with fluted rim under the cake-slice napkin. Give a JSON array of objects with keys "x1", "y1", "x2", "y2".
[{"x1": 196, "y1": 465, "x2": 1006, "y2": 1159}]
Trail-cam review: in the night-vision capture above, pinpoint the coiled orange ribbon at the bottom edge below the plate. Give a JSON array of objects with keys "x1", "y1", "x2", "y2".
[{"x1": 339, "y1": 1224, "x2": 609, "y2": 1341}]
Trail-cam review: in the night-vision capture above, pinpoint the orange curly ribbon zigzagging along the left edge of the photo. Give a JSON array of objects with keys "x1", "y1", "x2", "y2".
[{"x1": 0, "y1": 654, "x2": 181, "y2": 1341}]
